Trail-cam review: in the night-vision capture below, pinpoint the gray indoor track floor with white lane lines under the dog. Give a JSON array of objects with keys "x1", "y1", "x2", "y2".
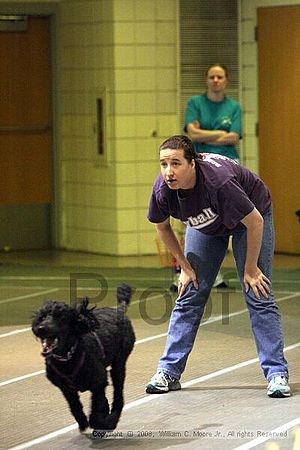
[{"x1": 0, "y1": 252, "x2": 300, "y2": 450}]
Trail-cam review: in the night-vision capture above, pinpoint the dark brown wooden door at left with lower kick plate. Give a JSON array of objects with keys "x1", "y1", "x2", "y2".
[{"x1": 0, "y1": 17, "x2": 52, "y2": 248}]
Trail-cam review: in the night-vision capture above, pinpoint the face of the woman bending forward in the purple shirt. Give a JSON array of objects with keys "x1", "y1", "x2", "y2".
[{"x1": 160, "y1": 148, "x2": 196, "y2": 189}]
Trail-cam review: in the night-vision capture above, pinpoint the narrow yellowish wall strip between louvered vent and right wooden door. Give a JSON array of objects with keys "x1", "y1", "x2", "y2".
[{"x1": 240, "y1": 0, "x2": 300, "y2": 172}]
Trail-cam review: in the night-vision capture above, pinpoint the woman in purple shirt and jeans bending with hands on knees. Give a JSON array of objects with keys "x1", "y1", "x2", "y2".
[{"x1": 146, "y1": 136, "x2": 290, "y2": 397}]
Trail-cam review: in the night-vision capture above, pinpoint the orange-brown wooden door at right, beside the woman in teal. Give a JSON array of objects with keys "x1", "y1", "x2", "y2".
[{"x1": 258, "y1": 6, "x2": 300, "y2": 254}]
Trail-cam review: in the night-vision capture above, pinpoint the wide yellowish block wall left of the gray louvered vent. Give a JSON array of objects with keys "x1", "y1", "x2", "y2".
[{"x1": 59, "y1": 0, "x2": 178, "y2": 255}]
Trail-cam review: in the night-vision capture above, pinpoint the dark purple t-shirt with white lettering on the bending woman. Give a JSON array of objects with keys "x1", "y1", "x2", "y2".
[{"x1": 147, "y1": 153, "x2": 271, "y2": 235}]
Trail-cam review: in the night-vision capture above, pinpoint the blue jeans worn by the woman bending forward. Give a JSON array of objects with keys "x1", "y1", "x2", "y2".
[{"x1": 158, "y1": 207, "x2": 288, "y2": 381}]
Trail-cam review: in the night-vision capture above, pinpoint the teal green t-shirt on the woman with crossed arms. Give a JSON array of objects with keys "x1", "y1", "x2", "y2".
[{"x1": 184, "y1": 94, "x2": 242, "y2": 159}]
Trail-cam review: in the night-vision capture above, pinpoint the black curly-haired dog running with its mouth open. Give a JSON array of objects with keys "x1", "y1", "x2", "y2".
[{"x1": 32, "y1": 284, "x2": 135, "y2": 432}]
